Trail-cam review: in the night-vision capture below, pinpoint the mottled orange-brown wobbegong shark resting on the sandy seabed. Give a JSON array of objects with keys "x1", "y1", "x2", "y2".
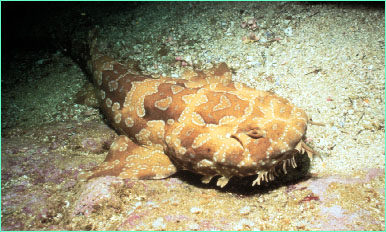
[{"x1": 83, "y1": 29, "x2": 311, "y2": 187}]
